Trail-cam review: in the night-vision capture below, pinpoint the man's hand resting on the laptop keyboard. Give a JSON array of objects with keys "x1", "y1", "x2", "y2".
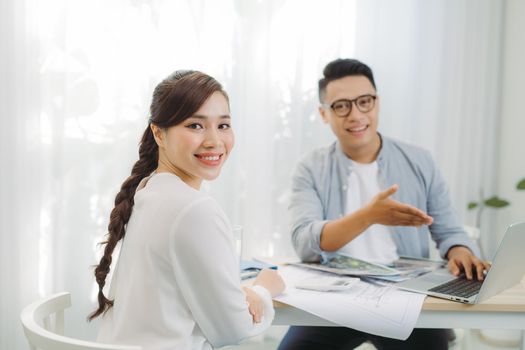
[{"x1": 447, "y1": 246, "x2": 490, "y2": 281}]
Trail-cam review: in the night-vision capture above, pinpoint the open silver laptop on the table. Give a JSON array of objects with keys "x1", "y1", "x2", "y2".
[{"x1": 396, "y1": 222, "x2": 525, "y2": 304}]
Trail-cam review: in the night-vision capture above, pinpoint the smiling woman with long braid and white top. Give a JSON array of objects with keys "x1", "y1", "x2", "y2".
[{"x1": 90, "y1": 71, "x2": 284, "y2": 349}]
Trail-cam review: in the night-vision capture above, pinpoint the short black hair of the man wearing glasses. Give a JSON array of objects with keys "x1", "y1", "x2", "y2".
[{"x1": 319, "y1": 58, "x2": 376, "y2": 103}]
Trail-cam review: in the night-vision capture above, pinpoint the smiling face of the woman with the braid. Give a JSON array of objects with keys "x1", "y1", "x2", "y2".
[{"x1": 152, "y1": 91, "x2": 234, "y2": 189}]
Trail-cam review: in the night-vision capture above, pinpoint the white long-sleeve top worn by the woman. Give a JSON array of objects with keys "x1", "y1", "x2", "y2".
[{"x1": 98, "y1": 173, "x2": 274, "y2": 350}]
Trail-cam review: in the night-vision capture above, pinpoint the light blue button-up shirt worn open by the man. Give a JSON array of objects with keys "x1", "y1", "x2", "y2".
[{"x1": 289, "y1": 136, "x2": 479, "y2": 261}]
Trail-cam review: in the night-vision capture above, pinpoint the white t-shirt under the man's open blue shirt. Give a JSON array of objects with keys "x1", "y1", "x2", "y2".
[{"x1": 339, "y1": 162, "x2": 398, "y2": 264}]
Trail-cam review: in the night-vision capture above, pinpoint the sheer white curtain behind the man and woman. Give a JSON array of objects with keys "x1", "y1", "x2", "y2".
[{"x1": 0, "y1": 0, "x2": 502, "y2": 349}]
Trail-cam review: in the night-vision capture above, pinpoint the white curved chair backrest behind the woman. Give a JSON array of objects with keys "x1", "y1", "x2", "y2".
[{"x1": 20, "y1": 292, "x2": 141, "y2": 350}]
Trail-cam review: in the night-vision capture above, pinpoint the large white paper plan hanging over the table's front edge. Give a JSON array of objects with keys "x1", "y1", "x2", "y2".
[{"x1": 275, "y1": 266, "x2": 425, "y2": 340}]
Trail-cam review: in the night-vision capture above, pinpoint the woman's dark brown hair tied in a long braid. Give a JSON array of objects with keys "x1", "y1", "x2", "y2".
[{"x1": 88, "y1": 71, "x2": 228, "y2": 321}]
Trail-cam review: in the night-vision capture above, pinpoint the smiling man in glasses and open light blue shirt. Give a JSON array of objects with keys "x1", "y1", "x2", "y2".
[{"x1": 279, "y1": 59, "x2": 487, "y2": 350}]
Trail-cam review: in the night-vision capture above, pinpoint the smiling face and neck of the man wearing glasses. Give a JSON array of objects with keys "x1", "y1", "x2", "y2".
[{"x1": 319, "y1": 75, "x2": 380, "y2": 161}]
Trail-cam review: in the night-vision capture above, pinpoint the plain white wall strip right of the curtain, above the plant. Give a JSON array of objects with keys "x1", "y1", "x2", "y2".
[{"x1": 492, "y1": 0, "x2": 525, "y2": 252}]
